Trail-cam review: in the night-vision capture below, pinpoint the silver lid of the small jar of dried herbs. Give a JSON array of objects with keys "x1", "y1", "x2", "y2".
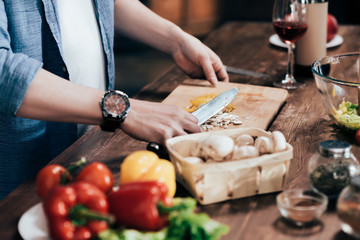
[{"x1": 319, "y1": 140, "x2": 351, "y2": 158}]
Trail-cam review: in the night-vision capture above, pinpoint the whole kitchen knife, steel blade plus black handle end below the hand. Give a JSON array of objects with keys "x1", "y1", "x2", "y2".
[{"x1": 146, "y1": 88, "x2": 239, "y2": 159}]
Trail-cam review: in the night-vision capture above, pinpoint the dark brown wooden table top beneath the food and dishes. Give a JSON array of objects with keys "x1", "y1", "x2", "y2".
[{"x1": 0, "y1": 22, "x2": 360, "y2": 240}]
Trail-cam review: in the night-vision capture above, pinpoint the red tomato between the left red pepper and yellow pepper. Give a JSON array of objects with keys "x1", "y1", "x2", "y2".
[{"x1": 75, "y1": 162, "x2": 114, "y2": 193}]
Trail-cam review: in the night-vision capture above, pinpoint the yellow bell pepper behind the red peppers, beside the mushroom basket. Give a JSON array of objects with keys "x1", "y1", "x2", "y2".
[{"x1": 120, "y1": 150, "x2": 176, "y2": 197}]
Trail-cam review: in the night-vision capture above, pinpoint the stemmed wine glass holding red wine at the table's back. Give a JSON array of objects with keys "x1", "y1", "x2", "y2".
[{"x1": 272, "y1": 0, "x2": 307, "y2": 89}]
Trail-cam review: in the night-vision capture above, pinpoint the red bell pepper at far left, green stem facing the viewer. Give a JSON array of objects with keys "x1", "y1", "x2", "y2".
[{"x1": 43, "y1": 182, "x2": 113, "y2": 240}]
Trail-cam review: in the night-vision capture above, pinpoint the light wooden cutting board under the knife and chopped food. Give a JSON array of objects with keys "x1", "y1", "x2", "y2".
[{"x1": 163, "y1": 79, "x2": 288, "y2": 130}]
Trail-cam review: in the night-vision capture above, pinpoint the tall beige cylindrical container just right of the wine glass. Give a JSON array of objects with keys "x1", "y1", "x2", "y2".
[{"x1": 295, "y1": 0, "x2": 328, "y2": 74}]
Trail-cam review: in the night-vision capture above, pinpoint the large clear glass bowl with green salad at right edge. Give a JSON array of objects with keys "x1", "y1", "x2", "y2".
[{"x1": 312, "y1": 52, "x2": 360, "y2": 132}]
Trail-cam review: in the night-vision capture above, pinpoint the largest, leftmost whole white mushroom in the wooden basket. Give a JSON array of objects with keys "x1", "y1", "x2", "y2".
[{"x1": 199, "y1": 134, "x2": 234, "y2": 161}]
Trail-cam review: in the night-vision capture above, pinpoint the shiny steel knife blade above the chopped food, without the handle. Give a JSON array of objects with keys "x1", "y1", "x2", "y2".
[{"x1": 192, "y1": 88, "x2": 239, "y2": 125}]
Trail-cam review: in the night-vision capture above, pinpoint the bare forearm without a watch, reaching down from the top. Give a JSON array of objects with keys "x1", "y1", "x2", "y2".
[{"x1": 114, "y1": 0, "x2": 187, "y2": 54}]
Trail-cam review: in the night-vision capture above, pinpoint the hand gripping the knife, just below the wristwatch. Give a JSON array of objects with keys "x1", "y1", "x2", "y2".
[{"x1": 121, "y1": 99, "x2": 200, "y2": 144}]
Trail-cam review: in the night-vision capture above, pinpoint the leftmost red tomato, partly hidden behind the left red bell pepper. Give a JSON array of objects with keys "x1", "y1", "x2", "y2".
[{"x1": 36, "y1": 164, "x2": 71, "y2": 199}]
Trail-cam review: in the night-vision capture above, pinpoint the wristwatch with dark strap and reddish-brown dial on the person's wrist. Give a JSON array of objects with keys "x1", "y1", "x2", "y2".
[{"x1": 100, "y1": 90, "x2": 130, "y2": 132}]
